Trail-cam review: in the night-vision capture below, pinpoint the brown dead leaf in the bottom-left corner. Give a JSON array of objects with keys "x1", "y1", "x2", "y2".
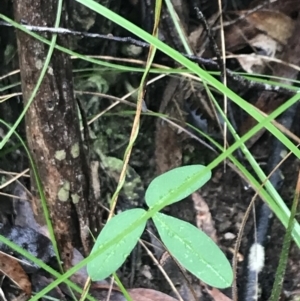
[{"x1": 0, "y1": 251, "x2": 31, "y2": 296}]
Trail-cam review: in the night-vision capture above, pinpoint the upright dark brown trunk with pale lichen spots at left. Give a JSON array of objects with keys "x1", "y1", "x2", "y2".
[{"x1": 14, "y1": 0, "x2": 99, "y2": 268}]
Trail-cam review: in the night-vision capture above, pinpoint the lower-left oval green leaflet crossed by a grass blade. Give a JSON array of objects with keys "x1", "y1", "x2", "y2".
[{"x1": 87, "y1": 209, "x2": 146, "y2": 281}]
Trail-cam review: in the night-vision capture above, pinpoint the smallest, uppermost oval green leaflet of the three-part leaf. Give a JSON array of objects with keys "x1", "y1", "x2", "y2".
[{"x1": 145, "y1": 165, "x2": 211, "y2": 207}]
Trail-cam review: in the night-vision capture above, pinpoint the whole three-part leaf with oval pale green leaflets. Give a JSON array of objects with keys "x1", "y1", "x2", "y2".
[{"x1": 87, "y1": 165, "x2": 233, "y2": 288}]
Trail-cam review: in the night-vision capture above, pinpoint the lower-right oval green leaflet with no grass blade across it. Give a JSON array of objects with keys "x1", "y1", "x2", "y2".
[{"x1": 153, "y1": 212, "x2": 233, "y2": 288}]
